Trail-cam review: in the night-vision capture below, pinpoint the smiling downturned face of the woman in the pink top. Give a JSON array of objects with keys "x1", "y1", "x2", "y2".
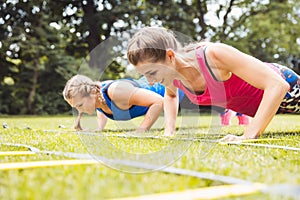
[{"x1": 135, "y1": 62, "x2": 176, "y2": 86}]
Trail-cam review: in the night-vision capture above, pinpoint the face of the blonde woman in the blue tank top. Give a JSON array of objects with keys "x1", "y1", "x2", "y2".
[{"x1": 68, "y1": 94, "x2": 96, "y2": 115}]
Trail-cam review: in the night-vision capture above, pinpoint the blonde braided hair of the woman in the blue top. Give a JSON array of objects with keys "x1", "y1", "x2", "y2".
[{"x1": 63, "y1": 75, "x2": 100, "y2": 100}]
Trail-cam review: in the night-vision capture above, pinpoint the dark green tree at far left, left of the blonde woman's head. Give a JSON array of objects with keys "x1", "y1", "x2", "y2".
[{"x1": 0, "y1": 1, "x2": 76, "y2": 114}]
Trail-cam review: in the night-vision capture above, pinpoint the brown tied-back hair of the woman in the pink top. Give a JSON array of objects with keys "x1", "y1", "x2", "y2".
[{"x1": 127, "y1": 27, "x2": 181, "y2": 65}]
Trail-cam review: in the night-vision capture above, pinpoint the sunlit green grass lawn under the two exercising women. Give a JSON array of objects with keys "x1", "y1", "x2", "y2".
[{"x1": 0, "y1": 115, "x2": 300, "y2": 199}]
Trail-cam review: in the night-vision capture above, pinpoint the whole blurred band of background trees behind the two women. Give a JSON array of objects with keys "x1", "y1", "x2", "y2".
[{"x1": 0, "y1": 0, "x2": 300, "y2": 114}]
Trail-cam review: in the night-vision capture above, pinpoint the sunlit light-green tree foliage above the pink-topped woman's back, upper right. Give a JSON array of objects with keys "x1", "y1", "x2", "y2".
[{"x1": 212, "y1": 0, "x2": 300, "y2": 66}]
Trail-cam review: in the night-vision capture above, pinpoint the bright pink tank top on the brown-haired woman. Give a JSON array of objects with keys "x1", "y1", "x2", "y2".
[{"x1": 173, "y1": 48, "x2": 280, "y2": 117}]
